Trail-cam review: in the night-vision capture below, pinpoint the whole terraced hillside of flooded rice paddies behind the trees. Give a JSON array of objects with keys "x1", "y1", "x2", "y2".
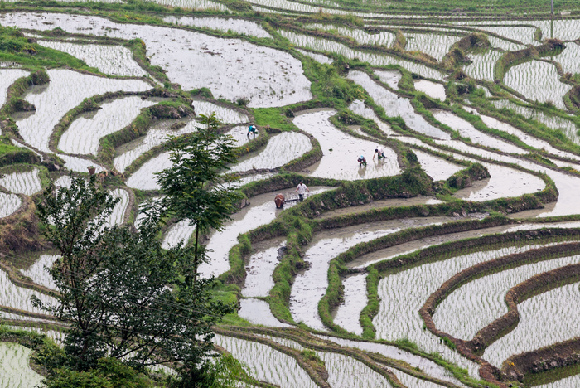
[{"x1": 0, "y1": 0, "x2": 580, "y2": 388}]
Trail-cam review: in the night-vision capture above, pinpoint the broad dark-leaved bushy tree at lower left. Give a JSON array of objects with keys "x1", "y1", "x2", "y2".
[{"x1": 36, "y1": 177, "x2": 230, "y2": 376}]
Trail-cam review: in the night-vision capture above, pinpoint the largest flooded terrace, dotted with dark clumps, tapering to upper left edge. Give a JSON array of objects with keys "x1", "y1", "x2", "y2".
[{"x1": 0, "y1": 13, "x2": 312, "y2": 108}]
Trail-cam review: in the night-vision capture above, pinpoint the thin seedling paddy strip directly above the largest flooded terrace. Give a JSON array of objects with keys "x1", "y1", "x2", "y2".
[{"x1": 163, "y1": 16, "x2": 272, "y2": 38}]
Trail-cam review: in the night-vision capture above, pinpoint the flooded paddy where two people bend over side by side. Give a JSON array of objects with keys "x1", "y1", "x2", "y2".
[{"x1": 293, "y1": 110, "x2": 400, "y2": 180}]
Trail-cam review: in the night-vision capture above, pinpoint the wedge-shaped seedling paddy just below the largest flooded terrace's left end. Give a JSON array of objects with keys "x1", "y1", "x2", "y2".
[{"x1": 38, "y1": 40, "x2": 147, "y2": 77}]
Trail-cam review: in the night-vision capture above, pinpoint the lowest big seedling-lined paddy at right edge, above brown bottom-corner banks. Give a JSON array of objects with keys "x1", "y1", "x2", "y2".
[{"x1": 483, "y1": 283, "x2": 580, "y2": 366}]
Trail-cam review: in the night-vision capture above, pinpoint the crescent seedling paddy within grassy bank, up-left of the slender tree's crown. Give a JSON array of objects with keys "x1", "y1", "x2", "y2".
[{"x1": 58, "y1": 96, "x2": 155, "y2": 155}]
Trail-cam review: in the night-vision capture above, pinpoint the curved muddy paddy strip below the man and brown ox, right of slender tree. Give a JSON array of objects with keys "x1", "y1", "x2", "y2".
[{"x1": 198, "y1": 187, "x2": 332, "y2": 278}]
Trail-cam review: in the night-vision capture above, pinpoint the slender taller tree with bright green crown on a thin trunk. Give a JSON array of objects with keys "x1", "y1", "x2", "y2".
[{"x1": 158, "y1": 113, "x2": 240, "y2": 388}]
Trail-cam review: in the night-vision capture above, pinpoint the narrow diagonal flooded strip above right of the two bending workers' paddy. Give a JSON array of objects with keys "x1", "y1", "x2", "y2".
[{"x1": 348, "y1": 70, "x2": 451, "y2": 139}]
